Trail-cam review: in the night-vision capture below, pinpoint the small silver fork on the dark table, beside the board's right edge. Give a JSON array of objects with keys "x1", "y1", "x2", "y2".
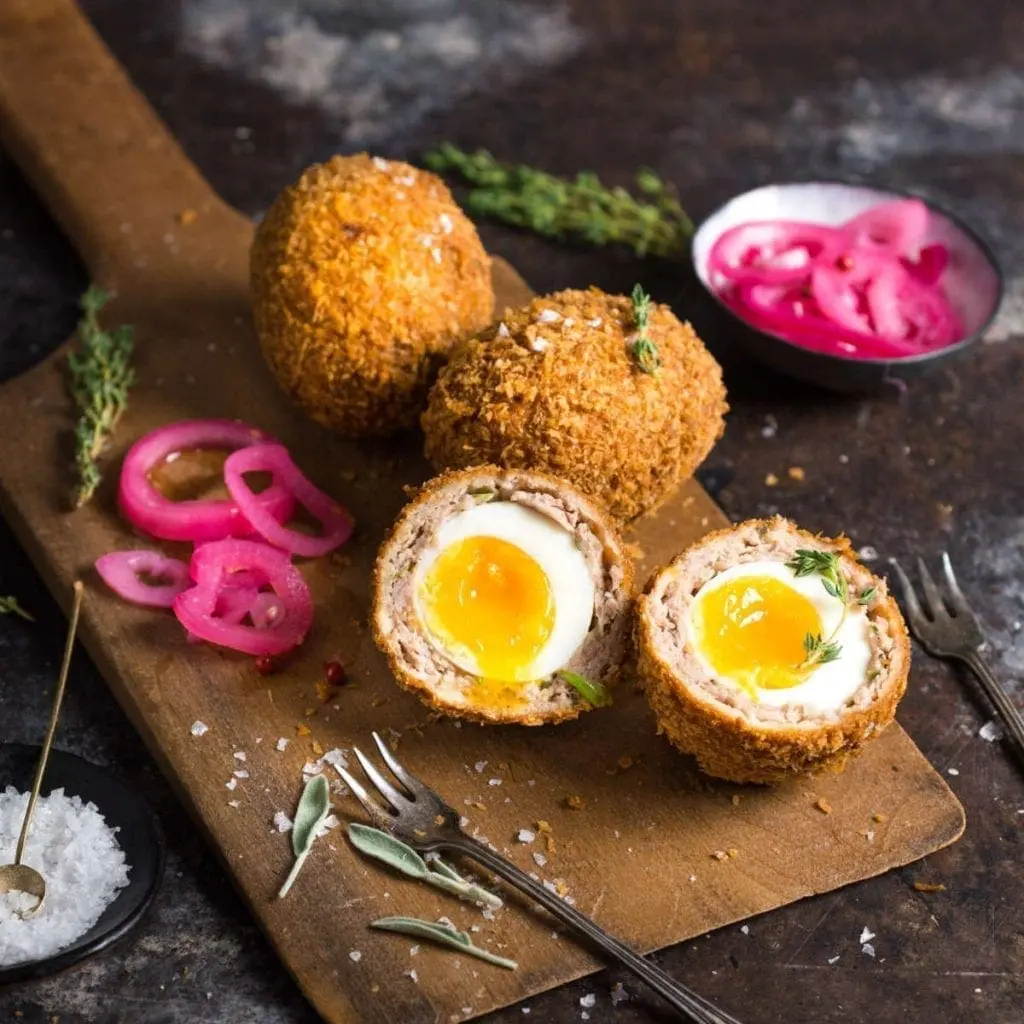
[{"x1": 892, "y1": 552, "x2": 1024, "y2": 758}]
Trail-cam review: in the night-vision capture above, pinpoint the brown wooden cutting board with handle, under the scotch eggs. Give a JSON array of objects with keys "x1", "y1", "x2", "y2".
[{"x1": 0, "y1": 0, "x2": 964, "y2": 1024}]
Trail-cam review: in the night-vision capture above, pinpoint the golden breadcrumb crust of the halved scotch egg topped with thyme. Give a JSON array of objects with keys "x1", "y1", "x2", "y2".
[{"x1": 635, "y1": 518, "x2": 910, "y2": 784}]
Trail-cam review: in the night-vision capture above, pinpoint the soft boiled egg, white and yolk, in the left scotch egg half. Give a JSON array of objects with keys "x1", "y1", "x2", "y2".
[{"x1": 414, "y1": 501, "x2": 595, "y2": 683}]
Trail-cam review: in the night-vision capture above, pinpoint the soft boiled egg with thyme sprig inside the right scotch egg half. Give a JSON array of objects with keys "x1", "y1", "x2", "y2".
[{"x1": 687, "y1": 560, "x2": 871, "y2": 711}]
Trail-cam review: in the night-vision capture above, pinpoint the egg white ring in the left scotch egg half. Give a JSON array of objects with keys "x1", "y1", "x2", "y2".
[{"x1": 413, "y1": 502, "x2": 595, "y2": 681}]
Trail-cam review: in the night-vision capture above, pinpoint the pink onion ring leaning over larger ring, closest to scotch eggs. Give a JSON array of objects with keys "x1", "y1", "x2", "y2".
[{"x1": 224, "y1": 444, "x2": 353, "y2": 558}]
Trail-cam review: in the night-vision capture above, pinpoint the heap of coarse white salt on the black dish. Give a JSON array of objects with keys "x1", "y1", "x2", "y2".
[{"x1": 0, "y1": 786, "x2": 129, "y2": 967}]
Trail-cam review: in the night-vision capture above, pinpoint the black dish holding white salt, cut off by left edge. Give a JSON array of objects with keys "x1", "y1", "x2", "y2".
[{"x1": 0, "y1": 743, "x2": 166, "y2": 985}]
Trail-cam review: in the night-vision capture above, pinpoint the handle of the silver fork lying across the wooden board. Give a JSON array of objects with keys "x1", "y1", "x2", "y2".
[{"x1": 444, "y1": 837, "x2": 739, "y2": 1024}]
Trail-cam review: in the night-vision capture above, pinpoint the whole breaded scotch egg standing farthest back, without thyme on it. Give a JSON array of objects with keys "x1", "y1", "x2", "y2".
[{"x1": 250, "y1": 154, "x2": 495, "y2": 437}]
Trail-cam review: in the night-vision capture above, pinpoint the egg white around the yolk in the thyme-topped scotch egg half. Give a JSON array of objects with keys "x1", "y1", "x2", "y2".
[{"x1": 686, "y1": 561, "x2": 871, "y2": 712}]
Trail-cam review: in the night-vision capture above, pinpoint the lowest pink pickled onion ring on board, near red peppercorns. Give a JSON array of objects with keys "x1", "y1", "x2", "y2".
[{"x1": 174, "y1": 538, "x2": 313, "y2": 656}]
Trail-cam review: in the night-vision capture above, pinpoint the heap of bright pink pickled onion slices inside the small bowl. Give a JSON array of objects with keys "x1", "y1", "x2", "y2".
[{"x1": 708, "y1": 200, "x2": 963, "y2": 359}]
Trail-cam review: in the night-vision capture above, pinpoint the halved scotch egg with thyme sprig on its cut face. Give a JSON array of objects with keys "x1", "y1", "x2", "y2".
[{"x1": 636, "y1": 517, "x2": 910, "y2": 783}]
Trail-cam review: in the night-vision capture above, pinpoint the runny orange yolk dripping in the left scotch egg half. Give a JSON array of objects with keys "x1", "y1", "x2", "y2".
[{"x1": 420, "y1": 537, "x2": 555, "y2": 682}]
